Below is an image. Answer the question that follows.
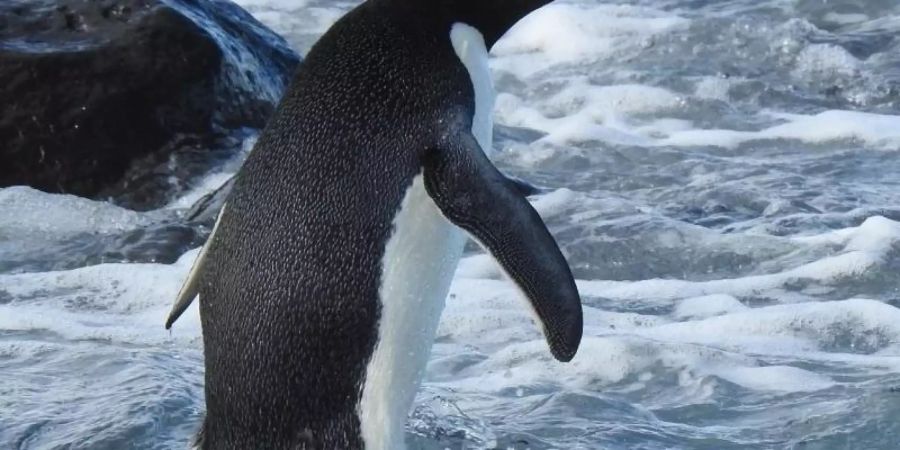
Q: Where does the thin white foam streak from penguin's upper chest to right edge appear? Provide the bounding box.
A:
[497,97,900,150]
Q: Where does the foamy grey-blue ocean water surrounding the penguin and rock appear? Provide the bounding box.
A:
[0,0,900,450]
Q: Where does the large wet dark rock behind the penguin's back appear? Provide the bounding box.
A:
[0,0,299,207]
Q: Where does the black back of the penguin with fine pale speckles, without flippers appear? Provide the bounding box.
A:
[200,0,474,449]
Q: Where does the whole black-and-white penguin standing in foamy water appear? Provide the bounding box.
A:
[165,0,582,450]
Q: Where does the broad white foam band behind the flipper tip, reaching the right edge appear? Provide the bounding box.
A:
[438,270,900,392]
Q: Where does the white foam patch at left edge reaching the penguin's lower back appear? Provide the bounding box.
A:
[0,250,200,344]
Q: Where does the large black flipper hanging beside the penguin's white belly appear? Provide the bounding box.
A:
[424,133,583,361]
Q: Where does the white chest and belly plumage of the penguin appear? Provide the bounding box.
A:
[358,23,494,450]
